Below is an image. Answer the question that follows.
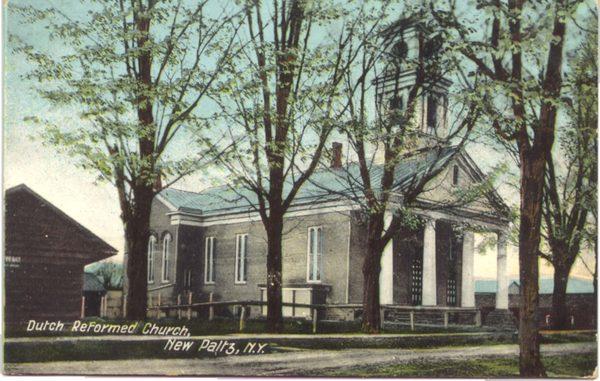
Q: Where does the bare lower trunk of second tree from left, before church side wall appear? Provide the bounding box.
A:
[267,215,283,333]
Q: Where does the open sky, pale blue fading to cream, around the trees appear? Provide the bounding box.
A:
[3,0,590,278]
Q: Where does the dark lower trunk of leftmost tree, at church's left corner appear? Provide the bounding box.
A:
[122,185,153,320]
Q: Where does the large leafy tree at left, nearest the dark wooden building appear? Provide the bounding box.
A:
[10,0,239,319]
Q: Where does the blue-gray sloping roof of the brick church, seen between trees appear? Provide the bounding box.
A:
[160,147,458,215]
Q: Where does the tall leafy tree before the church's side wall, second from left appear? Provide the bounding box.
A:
[201,0,390,331]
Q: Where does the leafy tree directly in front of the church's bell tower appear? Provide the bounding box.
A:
[323,13,489,333]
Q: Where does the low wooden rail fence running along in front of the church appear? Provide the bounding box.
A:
[148,293,481,333]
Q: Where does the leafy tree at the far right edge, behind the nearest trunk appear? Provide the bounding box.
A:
[540,17,598,329]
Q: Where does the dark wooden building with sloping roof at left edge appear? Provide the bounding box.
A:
[4,184,117,326]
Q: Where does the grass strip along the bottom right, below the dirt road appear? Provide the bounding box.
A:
[309,353,597,378]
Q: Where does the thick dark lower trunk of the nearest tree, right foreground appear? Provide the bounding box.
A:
[519,156,545,377]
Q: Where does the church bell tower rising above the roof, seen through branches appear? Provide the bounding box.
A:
[374,17,451,139]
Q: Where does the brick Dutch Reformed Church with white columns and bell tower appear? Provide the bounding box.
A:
[142,17,509,317]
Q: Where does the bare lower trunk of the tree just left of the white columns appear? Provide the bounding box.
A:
[362,233,381,333]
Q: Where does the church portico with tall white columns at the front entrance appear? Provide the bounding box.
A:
[380,212,508,310]
